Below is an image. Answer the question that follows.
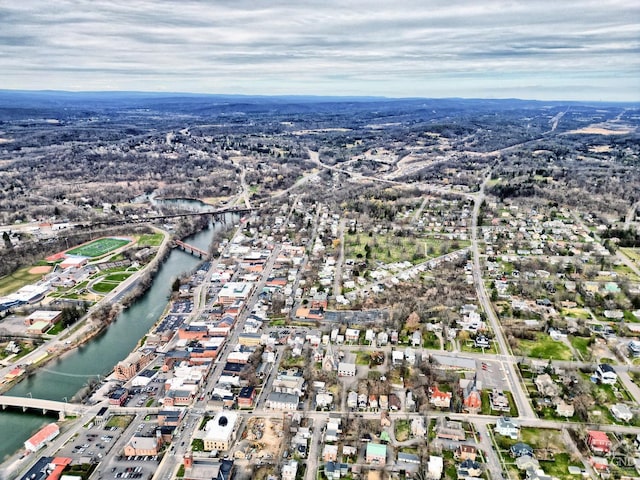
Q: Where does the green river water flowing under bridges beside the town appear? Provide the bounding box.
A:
[0,214,238,462]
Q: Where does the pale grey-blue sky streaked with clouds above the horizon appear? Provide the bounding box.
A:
[0,0,640,101]
